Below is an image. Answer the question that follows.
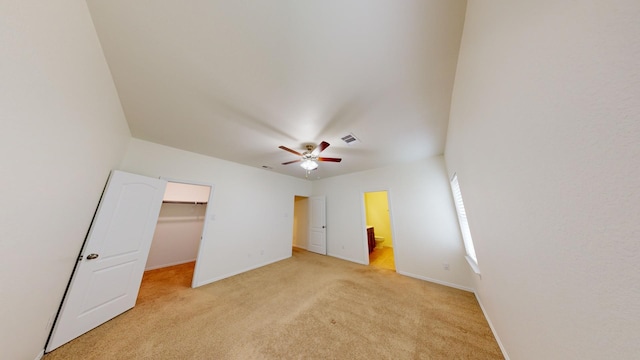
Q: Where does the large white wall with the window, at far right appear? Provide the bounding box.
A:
[445,0,640,360]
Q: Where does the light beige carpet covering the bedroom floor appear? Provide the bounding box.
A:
[43,249,503,360]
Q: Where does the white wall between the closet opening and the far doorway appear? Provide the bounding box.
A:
[121,139,311,284]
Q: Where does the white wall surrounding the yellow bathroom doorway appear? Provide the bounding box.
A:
[313,156,471,289]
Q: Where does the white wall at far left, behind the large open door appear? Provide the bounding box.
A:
[0,0,129,360]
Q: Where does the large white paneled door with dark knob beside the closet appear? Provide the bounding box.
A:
[46,171,166,352]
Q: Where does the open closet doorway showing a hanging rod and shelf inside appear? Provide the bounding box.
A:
[137,181,212,304]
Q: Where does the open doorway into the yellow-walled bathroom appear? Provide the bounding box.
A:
[364,190,396,271]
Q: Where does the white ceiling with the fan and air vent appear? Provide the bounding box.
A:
[87,0,466,179]
